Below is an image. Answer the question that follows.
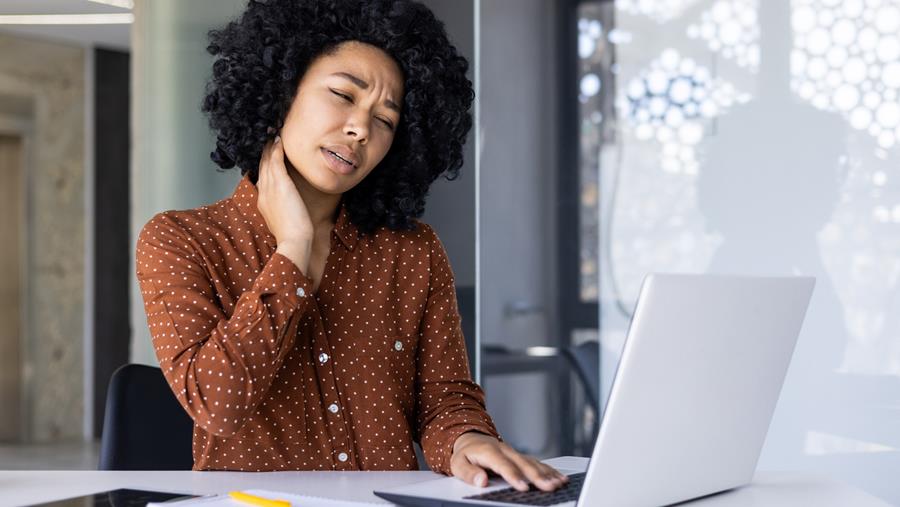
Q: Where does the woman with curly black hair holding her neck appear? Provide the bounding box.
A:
[136,0,566,490]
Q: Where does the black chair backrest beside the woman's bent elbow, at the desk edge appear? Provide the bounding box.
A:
[98,364,194,470]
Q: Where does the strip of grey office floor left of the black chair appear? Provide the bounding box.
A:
[0,442,100,470]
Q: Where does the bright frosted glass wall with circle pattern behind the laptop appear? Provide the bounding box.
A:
[577,0,900,502]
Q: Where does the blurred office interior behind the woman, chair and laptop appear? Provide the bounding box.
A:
[0,0,900,503]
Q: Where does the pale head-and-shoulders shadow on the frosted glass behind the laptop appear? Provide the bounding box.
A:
[698,87,900,500]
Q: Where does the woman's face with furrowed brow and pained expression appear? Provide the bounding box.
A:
[281,41,403,194]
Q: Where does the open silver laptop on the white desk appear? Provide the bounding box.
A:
[374,274,815,507]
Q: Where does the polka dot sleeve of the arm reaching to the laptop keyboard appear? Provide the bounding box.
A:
[416,224,500,475]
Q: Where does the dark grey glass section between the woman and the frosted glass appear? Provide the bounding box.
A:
[475,0,598,456]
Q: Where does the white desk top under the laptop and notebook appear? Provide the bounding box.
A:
[0,458,889,507]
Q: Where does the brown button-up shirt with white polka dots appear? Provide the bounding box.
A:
[136,177,498,473]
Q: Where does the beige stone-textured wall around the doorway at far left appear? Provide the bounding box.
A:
[0,34,85,442]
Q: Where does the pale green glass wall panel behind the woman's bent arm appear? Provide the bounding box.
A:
[130,0,246,366]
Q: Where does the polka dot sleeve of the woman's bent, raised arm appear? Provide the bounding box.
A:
[135,213,312,437]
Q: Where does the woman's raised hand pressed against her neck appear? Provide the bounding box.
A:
[256,137,314,274]
